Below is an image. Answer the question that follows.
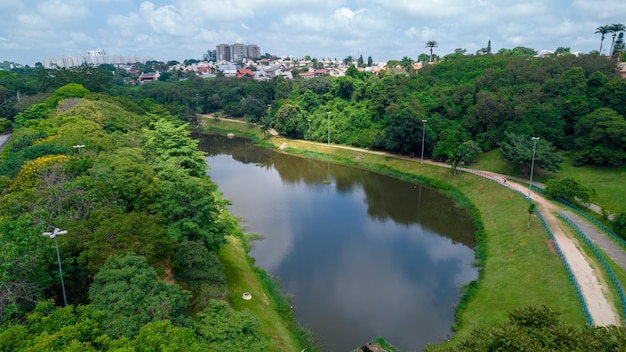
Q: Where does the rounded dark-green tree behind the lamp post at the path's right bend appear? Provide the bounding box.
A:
[500,133,563,175]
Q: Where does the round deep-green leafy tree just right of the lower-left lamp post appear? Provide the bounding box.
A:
[89,253,191,337]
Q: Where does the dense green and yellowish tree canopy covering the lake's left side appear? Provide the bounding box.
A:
[0,84,267,351]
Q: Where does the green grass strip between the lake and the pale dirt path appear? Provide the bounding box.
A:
[201,120,585,341]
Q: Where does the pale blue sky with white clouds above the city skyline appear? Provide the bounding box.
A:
[0,0,626,65]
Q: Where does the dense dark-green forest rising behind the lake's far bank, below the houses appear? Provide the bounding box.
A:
[123,55,626,167]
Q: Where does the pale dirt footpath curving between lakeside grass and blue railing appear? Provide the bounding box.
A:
[204,119,621,326]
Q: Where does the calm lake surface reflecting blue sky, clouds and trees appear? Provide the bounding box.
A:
[195,136,477,351]
